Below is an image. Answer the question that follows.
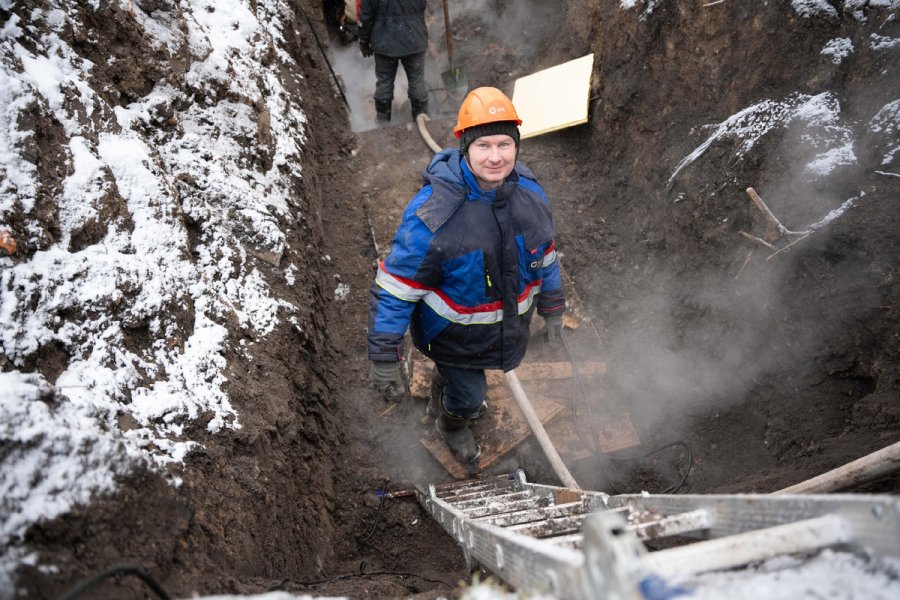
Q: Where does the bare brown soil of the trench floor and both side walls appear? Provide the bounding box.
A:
[12,0,900,598]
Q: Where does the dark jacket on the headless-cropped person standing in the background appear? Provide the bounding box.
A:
[357,0,428,58]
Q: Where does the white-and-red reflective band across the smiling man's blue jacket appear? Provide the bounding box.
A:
[375,263,541,325]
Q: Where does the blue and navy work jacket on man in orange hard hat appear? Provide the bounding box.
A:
[368,149,566,371]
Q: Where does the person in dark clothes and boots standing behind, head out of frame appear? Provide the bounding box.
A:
[358,0,428,123]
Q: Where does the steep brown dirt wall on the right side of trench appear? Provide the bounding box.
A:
[544,2,900,490]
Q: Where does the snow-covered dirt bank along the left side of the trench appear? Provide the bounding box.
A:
[0,0,305,589]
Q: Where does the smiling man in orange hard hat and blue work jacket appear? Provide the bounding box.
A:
[368,87,566,463]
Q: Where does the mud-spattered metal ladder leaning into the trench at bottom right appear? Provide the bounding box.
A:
[416,470,900,599]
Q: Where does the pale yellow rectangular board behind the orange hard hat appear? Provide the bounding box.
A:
[512,54,594,139]
